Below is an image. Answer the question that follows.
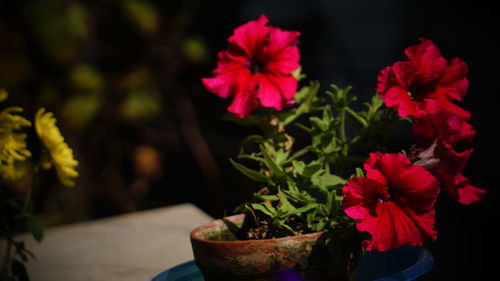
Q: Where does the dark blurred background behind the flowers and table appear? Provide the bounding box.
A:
[0,0,500,280]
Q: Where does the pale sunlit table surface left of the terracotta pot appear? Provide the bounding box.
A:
[0,204,212,281]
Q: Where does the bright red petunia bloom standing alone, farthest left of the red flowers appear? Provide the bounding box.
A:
[202,15,300,118]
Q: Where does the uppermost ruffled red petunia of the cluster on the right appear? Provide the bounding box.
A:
[377,39,470,118]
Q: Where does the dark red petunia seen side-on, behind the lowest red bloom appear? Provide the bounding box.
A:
[415,141,486,205]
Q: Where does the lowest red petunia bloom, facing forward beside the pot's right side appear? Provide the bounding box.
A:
[342,152,439,251]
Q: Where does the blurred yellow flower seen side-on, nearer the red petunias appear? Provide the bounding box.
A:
[35,108,78,186]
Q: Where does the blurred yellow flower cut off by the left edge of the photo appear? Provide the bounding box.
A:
[0,89,31,179]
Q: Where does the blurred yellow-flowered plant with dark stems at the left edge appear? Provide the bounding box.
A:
[0,88,78,281]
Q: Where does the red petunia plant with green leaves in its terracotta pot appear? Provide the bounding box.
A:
[191,15,485,281]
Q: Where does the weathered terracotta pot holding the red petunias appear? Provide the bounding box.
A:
[191,214,356,281]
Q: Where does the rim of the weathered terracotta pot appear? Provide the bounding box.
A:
[189,214,323,245]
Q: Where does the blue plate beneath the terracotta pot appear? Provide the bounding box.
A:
[152,246,434,281]
